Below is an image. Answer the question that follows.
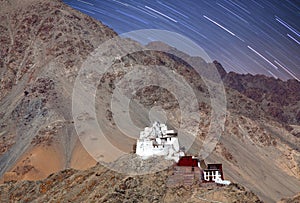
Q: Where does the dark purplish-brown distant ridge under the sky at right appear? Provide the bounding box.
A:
[223,72,300,125]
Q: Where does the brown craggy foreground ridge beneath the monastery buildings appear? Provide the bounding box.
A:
[0,159,261,203]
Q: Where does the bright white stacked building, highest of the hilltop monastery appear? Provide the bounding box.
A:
[136,121,184,162]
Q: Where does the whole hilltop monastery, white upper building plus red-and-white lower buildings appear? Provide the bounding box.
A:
[136,121,230,185]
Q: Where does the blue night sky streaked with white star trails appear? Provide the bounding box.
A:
[64,0,300,80]
